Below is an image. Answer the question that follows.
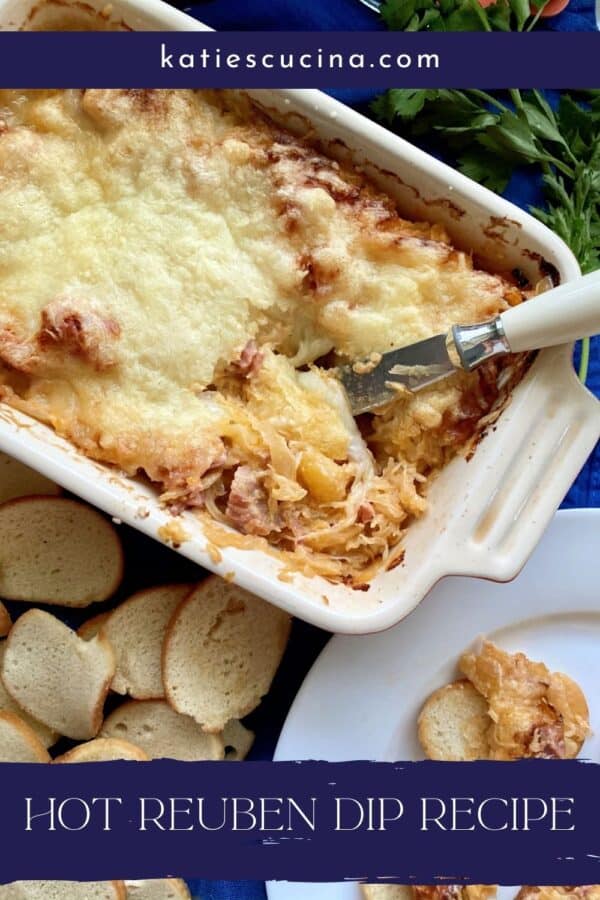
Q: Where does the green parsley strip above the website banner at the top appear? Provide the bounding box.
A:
[381,0,549,31]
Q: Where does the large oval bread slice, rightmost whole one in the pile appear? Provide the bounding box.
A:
[163,576,291,732]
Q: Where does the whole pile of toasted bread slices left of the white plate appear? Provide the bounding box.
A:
[0,454,291,900]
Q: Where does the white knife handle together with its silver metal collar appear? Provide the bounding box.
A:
[452,271,600,372]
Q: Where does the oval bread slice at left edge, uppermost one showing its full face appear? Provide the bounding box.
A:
[0,497,123,607]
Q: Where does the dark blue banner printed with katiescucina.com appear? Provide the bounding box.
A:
[0,31,600,89]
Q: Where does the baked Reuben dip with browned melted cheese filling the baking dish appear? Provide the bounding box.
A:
[0,90,521,586]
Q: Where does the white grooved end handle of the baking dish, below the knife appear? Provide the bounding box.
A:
[446,347,600,581]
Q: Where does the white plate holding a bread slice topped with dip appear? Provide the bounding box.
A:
[267,509,600,900]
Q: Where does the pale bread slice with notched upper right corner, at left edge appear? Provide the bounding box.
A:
[0,609,115,740]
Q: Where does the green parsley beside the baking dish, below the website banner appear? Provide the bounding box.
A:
[372,89,600,380]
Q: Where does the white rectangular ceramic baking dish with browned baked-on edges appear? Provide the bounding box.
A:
[0,0,600,633]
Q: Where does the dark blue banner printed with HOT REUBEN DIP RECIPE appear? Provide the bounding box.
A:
[0,760,600,885]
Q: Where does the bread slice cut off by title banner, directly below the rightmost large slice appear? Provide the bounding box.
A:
[100,700,224,761]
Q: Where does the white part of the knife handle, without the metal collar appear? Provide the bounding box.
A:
[499,271,600,353]
